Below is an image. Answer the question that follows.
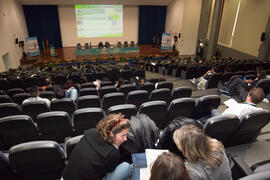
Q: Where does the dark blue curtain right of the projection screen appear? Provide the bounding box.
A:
[139,6,167,44]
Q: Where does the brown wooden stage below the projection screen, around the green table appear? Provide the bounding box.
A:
[21,44,178,65]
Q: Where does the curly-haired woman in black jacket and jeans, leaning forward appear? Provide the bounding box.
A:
[63,114,132,180]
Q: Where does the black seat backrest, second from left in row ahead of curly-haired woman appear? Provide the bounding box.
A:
[36,111,72,143]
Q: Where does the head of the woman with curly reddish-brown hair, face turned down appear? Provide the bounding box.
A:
[96,113,130,146]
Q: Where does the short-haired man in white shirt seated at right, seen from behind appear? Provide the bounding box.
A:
[211,87,265,120]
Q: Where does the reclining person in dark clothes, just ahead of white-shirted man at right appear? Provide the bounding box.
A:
[220,66,266,101]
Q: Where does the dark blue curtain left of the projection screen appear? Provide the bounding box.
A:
[23,5,62,48]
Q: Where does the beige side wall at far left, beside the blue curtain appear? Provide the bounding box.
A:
[0,0,28,72]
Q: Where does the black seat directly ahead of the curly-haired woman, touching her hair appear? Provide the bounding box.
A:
[72,108,105,135]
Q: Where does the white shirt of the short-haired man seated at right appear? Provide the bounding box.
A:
[222,103,263,120]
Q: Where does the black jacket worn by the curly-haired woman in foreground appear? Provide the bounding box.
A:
[63,129,120,180]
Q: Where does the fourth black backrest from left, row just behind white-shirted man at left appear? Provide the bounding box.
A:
[77,95,101,109]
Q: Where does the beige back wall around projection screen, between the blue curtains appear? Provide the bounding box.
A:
[58,5,139,47]
